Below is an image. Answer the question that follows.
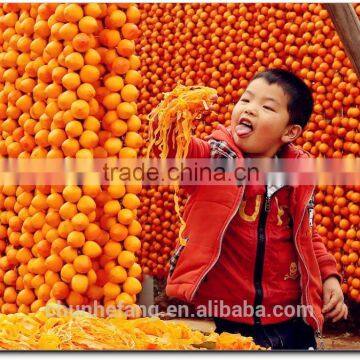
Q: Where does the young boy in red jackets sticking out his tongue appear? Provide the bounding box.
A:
[162,70,347,349]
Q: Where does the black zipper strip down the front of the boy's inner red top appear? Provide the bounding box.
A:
[254,186,270,325]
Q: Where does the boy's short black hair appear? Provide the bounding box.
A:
[251,69,314,128]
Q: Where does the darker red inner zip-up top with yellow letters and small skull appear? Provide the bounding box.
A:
[194,185,301,325]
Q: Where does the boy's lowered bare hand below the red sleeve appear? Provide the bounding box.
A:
[322,276,348,322]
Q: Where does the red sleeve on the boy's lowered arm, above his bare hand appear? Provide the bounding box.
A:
[313,229,342,283]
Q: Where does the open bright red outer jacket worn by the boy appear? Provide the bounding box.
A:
[166,125,340,332]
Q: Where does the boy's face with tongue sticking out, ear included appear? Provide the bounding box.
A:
[231,79,301,157]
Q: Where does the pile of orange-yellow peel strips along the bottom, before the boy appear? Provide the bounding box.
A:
[0,304,262,350]
